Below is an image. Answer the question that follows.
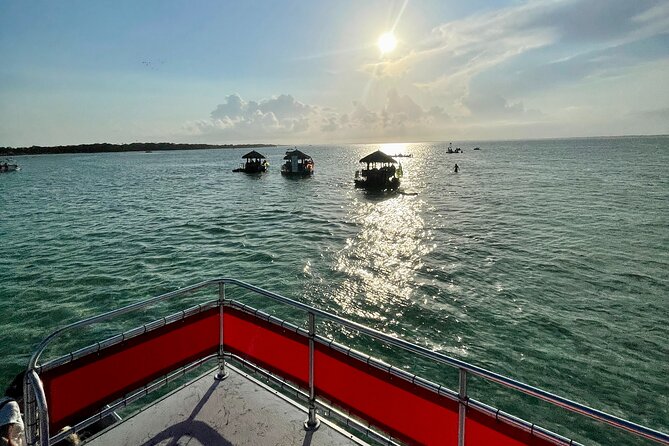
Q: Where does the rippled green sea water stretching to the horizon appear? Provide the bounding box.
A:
[0,137,669,444]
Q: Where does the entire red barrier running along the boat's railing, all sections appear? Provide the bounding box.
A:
[41,307,554,446]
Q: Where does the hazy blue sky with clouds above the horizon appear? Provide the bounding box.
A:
[0,0,669,147]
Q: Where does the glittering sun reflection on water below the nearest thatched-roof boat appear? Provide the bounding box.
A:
[332,195,432,323]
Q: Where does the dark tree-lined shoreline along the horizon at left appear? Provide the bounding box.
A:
[0,142,277,156]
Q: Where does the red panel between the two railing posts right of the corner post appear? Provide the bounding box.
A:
[314,344,458,445]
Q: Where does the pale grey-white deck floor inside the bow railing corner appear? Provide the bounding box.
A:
[86,368,365,446]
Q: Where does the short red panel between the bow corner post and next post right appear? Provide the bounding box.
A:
[223,307,309,387]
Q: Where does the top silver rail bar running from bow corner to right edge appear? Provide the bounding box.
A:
[218,278,669,444]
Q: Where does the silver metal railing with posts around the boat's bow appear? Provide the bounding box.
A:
[24,278,669,446]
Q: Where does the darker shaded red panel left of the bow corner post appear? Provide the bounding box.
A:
[40,308,219,434]
